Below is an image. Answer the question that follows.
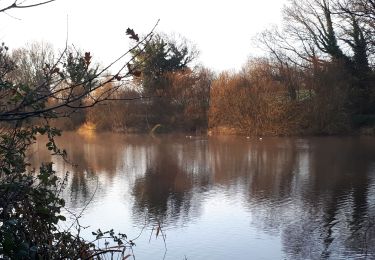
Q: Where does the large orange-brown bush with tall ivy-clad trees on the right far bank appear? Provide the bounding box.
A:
[208,0,375,135]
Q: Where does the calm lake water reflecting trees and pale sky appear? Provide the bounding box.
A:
[30,133,375,260]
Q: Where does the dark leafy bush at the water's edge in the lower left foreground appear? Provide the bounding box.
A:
[0,125,134,259]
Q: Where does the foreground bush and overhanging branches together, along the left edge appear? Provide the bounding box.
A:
[0,7,151,255]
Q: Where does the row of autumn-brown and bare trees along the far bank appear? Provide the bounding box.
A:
[12,0,375,135]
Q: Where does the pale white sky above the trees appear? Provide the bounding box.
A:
[0,0,286,71]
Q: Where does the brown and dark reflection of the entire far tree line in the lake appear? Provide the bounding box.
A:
[30,135,375,259]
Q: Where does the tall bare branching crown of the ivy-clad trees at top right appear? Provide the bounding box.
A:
[259,0,374,113]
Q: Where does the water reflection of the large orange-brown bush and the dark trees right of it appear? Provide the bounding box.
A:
[206,138,375,259]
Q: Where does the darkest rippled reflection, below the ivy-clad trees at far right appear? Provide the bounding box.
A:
[282,138,375,259]
